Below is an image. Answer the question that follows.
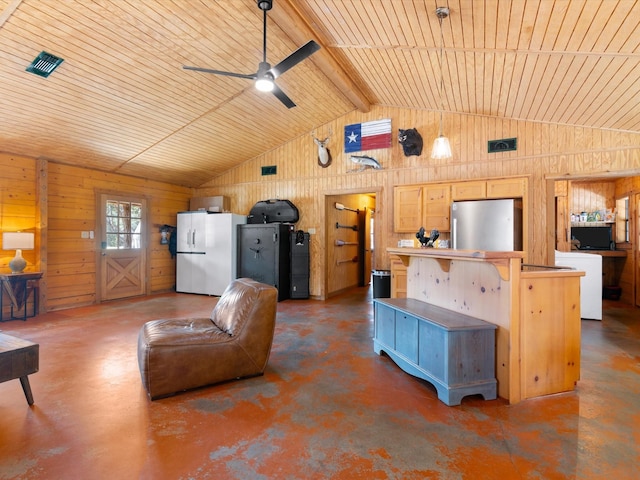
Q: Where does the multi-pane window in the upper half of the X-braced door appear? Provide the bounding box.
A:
[106,200,142,250]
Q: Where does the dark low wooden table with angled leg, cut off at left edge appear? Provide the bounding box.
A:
[0,333,40,405]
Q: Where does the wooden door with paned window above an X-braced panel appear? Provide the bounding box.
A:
[97,194,147,301]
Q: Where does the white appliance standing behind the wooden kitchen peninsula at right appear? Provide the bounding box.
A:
[556,250,602,320]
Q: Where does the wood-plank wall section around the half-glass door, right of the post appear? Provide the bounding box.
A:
[47,163,192,310]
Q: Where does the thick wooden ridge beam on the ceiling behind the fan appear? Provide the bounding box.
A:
[269,0,371,113]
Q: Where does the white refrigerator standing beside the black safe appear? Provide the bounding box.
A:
[176,211,247,295]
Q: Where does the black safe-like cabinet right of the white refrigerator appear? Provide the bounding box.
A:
[238,223,293,301]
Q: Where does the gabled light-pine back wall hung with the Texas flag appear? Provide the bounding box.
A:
[197,107,640,298]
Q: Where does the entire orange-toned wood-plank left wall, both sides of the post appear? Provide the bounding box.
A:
[0,155,193,310]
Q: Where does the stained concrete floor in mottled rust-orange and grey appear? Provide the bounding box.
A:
[0,288,640,480]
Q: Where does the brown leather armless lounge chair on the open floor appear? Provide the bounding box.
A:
[138,278,278,400]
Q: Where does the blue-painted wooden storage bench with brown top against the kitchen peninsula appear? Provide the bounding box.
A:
[373,298,497,406]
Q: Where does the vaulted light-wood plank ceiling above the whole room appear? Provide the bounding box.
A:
[0,0,640,186]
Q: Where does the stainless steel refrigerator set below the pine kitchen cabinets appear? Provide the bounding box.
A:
[451,199,522,251]
